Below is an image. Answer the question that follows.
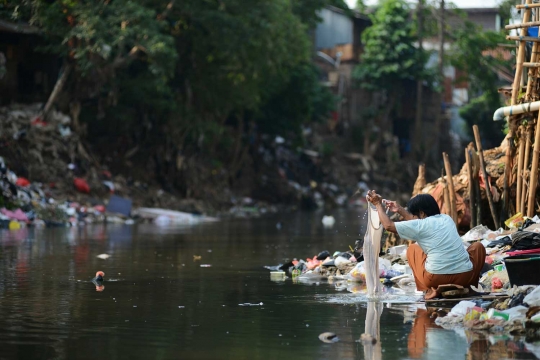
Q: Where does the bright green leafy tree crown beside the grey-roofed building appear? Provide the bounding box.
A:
[354,0,427,90]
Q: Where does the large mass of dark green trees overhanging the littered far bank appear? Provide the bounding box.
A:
[0,0,338,183]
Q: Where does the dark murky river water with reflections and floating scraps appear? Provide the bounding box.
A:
[0,210,540,360]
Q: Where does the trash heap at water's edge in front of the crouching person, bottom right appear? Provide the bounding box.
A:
[435,285,540,336]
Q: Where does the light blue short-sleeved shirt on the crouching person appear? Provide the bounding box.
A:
[395,214,473,274]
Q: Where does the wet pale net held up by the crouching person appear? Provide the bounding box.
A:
[364,202,383,299]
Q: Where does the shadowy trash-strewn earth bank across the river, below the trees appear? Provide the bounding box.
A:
[0,104,414,224]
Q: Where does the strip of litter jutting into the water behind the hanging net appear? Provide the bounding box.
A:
[265,240,416,292]
